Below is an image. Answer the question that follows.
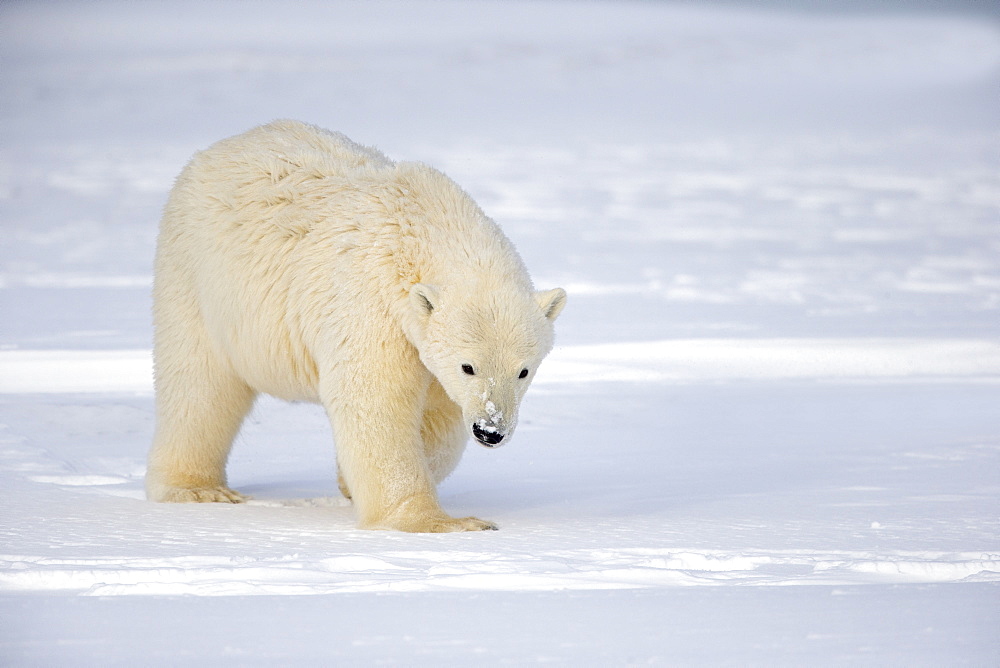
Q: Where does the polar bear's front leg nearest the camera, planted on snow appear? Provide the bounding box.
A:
[323,348,496,533]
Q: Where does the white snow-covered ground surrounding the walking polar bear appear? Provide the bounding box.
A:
[0,0,1000,666]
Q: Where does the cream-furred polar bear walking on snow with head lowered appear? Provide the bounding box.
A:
[146,121,566,532]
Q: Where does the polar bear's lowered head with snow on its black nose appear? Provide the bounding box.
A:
[408,283,566,448]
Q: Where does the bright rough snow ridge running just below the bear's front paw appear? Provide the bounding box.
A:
[0,548,1000,596]
